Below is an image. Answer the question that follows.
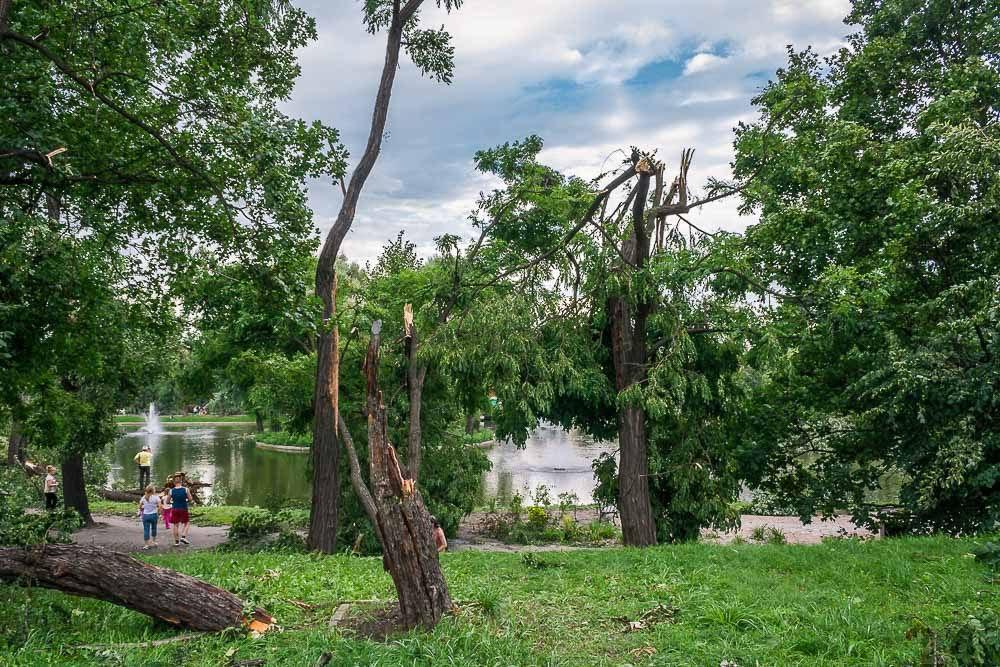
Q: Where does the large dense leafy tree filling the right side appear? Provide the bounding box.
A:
[736,0,1000,533]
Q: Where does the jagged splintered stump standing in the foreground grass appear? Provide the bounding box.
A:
[365,322,453,628]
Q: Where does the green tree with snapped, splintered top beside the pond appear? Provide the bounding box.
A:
[462,137,746,546]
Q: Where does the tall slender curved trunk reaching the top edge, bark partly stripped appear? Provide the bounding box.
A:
[308,0,423,553]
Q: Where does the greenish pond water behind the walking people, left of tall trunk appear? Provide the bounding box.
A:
[109,425,310,505]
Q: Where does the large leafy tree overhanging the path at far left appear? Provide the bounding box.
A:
[0,0,345,516]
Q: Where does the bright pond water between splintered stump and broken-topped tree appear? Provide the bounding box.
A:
[483,424,617,503]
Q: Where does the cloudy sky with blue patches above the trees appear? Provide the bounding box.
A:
[285,0,851,263]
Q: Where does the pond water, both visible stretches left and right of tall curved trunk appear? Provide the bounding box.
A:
[108,424,614,505]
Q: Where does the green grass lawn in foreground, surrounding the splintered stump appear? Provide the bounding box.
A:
[0,538,1000,667]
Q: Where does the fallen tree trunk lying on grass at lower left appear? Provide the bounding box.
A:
[0,544,273,632]
